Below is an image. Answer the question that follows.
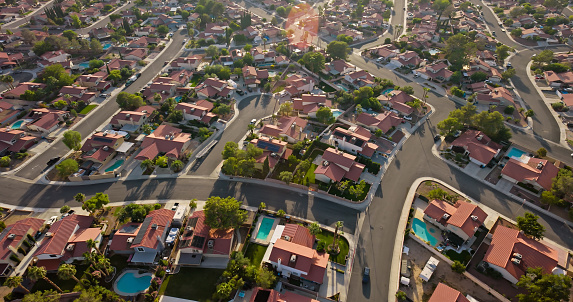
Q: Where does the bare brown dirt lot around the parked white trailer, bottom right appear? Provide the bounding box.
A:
[400,238,497,302]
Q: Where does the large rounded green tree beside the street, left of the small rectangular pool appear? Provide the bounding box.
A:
[204,196,247,230]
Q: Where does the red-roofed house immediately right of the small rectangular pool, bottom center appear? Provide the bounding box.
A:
[263,223,328,285]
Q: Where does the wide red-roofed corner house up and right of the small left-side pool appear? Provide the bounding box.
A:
[135,125,191,160]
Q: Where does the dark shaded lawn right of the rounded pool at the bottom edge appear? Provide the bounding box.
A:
[159,267,224,301]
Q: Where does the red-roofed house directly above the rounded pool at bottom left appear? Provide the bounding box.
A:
[109,209,175,264]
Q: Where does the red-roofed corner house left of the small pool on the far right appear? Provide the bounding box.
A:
[452,130,501,167]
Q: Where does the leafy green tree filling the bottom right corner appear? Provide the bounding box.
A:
[517,267,571,302]
